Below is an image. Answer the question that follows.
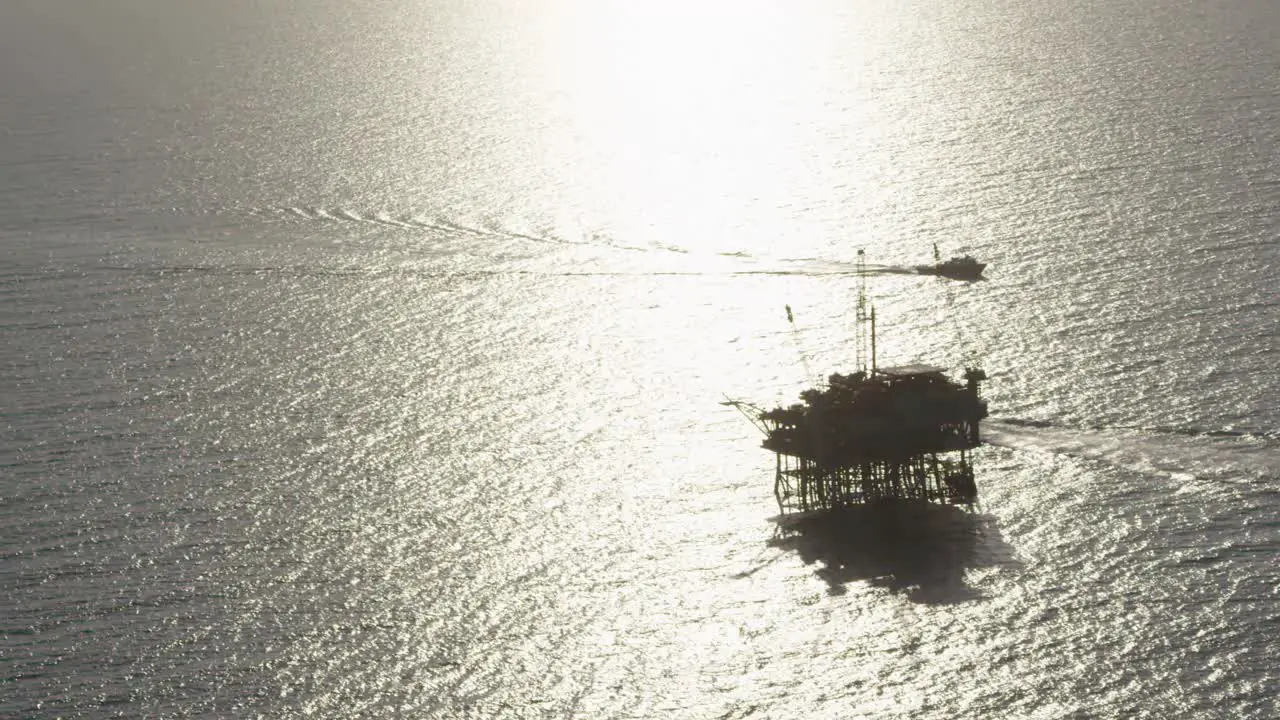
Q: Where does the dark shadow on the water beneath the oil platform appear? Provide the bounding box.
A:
[769,502,1015,605]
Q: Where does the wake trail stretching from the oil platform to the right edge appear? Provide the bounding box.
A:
[982,419,1280,482]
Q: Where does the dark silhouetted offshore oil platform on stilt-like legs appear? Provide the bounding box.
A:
[727,251,987,512]
